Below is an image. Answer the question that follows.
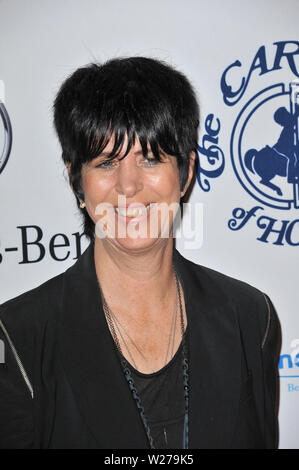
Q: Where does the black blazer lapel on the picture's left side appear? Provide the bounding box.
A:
[60,244,148,449]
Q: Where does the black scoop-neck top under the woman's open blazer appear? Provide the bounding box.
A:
[120,326,188,449]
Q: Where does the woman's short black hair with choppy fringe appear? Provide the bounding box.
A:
[54,57,199,239]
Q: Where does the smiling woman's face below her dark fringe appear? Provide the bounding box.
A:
[82,141,194,251]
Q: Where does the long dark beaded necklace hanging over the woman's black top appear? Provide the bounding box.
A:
[99,269,189,449]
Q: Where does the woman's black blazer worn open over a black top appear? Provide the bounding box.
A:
[0,244,279,449]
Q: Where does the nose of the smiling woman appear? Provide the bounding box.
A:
[115,155,143,198]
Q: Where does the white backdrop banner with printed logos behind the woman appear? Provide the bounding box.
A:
[0,0,299,449]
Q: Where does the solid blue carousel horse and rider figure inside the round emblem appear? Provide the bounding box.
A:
[244,106,299,196]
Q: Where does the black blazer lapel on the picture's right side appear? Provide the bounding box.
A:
[174,251,241,449]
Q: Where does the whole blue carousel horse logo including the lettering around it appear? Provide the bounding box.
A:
[197,41,299,246]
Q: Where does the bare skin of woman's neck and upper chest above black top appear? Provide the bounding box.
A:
[95,239,187,373]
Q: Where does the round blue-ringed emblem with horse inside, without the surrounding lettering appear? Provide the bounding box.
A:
[231,83,299,209]
